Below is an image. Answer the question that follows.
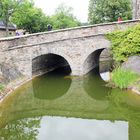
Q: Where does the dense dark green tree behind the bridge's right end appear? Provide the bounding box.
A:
[88,0,132,24]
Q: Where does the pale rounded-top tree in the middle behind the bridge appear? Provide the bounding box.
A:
[51,4,80,29]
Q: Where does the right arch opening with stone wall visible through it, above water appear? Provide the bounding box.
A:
[83,48,113,74]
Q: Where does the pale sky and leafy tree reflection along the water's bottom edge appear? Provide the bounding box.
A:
[0,116,128,140]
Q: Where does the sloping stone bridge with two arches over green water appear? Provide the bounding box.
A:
[0,20,140,85]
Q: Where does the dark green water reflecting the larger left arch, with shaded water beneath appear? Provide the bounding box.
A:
[32,67,71,100]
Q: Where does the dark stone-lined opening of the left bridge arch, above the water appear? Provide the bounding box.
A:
[32,53,72,76]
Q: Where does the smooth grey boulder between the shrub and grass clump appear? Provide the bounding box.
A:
[122,56,140,74]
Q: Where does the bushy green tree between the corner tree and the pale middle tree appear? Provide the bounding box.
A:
[11,0,49,33]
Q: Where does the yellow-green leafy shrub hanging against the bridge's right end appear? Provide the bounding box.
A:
[107,24,140,62]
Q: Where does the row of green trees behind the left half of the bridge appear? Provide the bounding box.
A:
[0,0,80,33]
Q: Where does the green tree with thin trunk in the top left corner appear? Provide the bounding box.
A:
[0,0,22,36]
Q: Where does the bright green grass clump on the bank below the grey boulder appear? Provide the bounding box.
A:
[112,67,139,89]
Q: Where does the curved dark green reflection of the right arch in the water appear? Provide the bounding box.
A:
[83,68,111,100]
